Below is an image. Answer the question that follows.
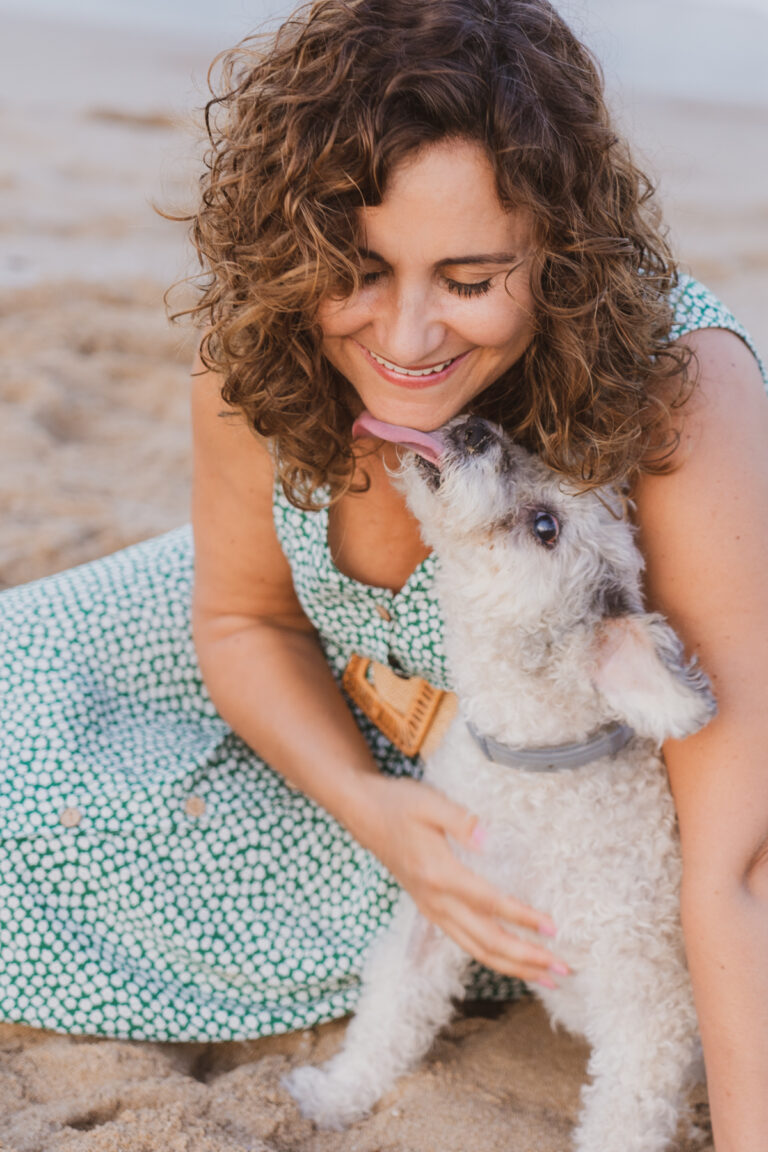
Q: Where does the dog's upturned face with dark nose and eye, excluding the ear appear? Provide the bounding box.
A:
[402,416,642,627]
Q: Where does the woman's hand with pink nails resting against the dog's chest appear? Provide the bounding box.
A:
[350,775,569,987]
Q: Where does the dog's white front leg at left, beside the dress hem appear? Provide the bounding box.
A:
[283,893,469,1129]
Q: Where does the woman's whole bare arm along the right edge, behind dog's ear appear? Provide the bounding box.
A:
[638,331,768,1152]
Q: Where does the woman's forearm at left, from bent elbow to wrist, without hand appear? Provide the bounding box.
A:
[195,621,380,839]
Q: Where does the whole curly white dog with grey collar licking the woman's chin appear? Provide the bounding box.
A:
[284,417,715,1152]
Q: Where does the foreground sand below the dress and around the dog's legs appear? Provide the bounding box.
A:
[0,1000,712,1152]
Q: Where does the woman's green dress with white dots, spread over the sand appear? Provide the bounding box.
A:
[0,280,764,1040]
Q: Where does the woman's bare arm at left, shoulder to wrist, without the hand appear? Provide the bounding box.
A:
[192,354,375,823]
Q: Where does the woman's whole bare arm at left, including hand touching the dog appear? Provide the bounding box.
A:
[192,347,564,980]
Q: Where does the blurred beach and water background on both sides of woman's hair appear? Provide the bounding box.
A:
[0,0,768,585]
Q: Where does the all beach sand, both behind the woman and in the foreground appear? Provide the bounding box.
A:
[0,9,768,1152]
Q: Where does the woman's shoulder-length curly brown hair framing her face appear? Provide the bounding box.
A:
[177,0,691,508]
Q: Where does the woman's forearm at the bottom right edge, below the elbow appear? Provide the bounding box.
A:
[683,876,768,1152]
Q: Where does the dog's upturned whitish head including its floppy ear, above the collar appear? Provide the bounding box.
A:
[401,416,715,741]
